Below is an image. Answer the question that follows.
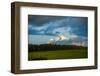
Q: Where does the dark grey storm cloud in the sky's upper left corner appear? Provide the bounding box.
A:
[28,15,69,26]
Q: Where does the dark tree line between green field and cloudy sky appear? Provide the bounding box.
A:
[28,44,87,52]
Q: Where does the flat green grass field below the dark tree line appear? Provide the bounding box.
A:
[28,49,88,61]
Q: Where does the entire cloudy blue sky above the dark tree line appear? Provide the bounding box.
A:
[28,15,88,46]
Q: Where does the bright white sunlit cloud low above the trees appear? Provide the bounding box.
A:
[48,35,87,46]
